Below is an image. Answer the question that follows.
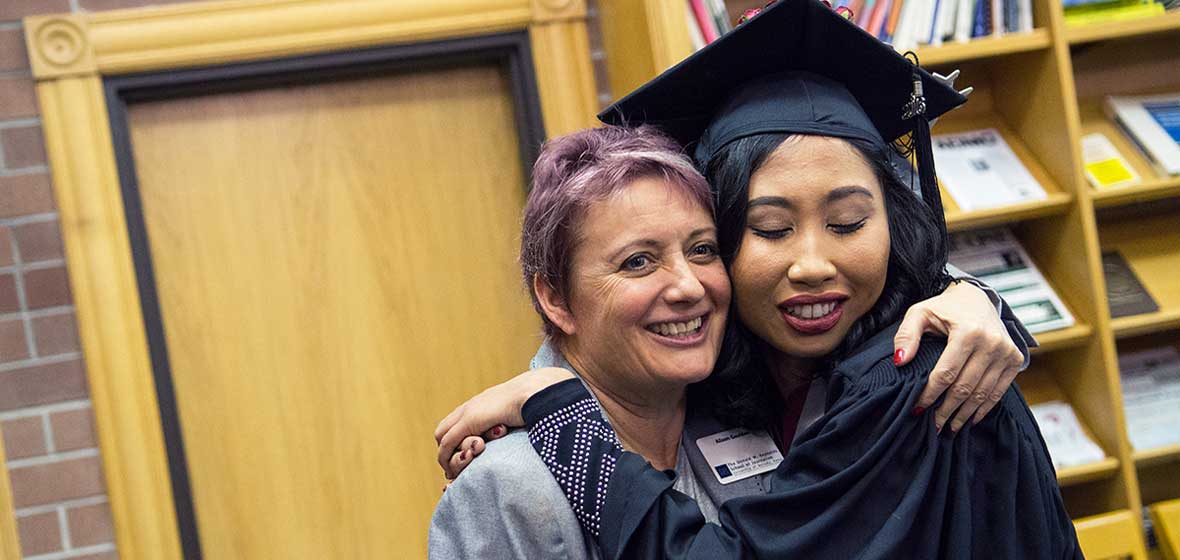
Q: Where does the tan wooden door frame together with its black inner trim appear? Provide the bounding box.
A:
[25,0,597,560]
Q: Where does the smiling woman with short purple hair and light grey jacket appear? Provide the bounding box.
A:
[430,120,1020,559]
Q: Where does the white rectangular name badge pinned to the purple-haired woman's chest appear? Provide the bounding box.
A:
[696,428,782,485]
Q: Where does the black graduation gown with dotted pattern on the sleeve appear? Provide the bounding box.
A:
[524,325,1082,560]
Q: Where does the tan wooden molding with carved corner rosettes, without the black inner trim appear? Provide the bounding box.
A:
[25,0,597,560]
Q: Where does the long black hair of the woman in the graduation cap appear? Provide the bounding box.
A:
[690,133,950,428]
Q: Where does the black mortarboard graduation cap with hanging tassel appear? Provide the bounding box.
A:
[598,0,966,236]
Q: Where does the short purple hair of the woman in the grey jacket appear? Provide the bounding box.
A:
[520,126,713,336]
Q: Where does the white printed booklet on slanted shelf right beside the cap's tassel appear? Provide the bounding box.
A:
[931,129,1048,212]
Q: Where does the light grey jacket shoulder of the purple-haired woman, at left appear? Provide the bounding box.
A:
[430,431,588,558]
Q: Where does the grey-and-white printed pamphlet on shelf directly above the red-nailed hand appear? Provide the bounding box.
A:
[950,228,1074,334]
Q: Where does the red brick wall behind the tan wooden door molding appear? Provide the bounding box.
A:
[0,0,610,560]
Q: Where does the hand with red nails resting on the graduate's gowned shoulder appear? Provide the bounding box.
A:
[893,282,1024,431]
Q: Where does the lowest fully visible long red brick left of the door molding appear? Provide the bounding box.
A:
[8,457,104,509]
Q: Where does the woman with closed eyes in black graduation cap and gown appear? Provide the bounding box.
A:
[443,0,1081,559]
